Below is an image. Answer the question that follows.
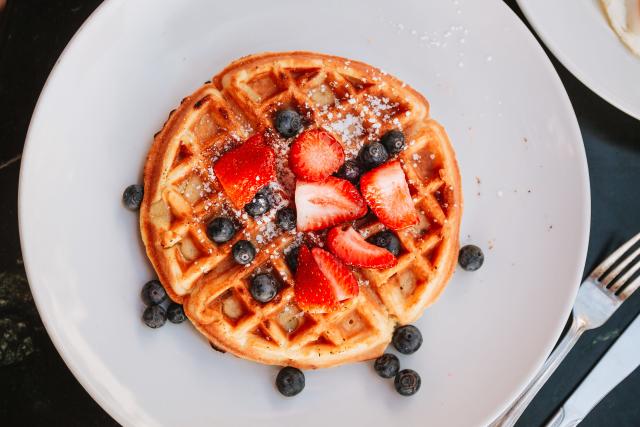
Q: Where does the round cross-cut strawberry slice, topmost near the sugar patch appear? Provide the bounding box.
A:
[289,129,344,181]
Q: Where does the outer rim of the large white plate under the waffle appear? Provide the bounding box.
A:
[18,0,591,425]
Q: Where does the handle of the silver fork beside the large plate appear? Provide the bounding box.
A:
[491,316,587,427]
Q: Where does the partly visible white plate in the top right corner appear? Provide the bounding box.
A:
[517,0,640,120]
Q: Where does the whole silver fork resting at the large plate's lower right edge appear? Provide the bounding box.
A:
[491,233,640,427]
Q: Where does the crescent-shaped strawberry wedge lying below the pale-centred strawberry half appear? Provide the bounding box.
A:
[327,226,398,268]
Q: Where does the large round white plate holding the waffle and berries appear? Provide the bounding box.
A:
[19,0,590,426]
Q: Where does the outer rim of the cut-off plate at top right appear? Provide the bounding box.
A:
[516,0,640,120]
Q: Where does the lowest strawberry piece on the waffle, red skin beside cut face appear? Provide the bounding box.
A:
[293,245,358,313]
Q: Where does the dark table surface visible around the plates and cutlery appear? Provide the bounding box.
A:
[0,0,640,427]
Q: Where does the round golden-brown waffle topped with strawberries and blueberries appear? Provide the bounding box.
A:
[140,52,462,369]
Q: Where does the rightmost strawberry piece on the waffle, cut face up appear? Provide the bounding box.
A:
[360,160,419,230]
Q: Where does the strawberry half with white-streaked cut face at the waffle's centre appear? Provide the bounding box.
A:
[295,176,367,231]
